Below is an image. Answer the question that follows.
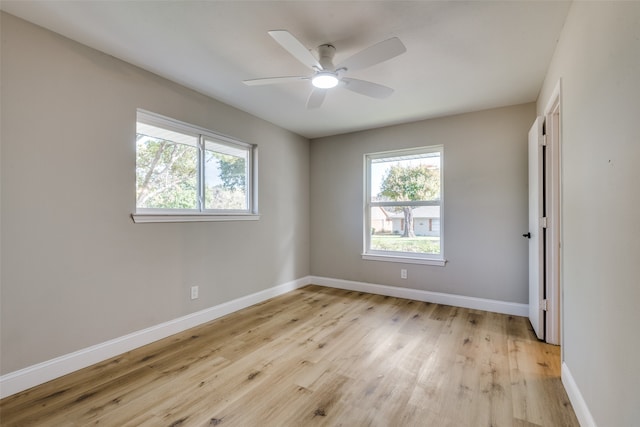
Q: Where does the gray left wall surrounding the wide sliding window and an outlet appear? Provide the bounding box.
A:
[0,13,309,374]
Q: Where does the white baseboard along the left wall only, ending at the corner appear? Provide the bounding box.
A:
[0,277,309,399]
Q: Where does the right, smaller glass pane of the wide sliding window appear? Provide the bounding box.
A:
[204,140,249,211]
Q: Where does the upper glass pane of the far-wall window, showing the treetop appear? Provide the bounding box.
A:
[369,152,440,202]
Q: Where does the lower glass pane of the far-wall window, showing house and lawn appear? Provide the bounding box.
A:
[370,206,440,255]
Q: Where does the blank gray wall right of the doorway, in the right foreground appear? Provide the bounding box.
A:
[538,2,640,427]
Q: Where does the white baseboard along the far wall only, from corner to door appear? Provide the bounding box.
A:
[309,276,529,317]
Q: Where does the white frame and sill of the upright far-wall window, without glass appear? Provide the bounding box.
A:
[362,145,446,267]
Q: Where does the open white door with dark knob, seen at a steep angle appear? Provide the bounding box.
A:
[529,117,545,339]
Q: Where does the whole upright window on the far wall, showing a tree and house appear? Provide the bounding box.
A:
[363,146,445,265]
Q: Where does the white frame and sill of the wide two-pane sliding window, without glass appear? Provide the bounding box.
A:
[131,109,260,223]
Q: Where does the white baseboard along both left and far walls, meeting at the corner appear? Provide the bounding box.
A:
[0,276,528,400]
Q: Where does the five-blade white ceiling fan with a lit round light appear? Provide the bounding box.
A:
[243,30,407,109]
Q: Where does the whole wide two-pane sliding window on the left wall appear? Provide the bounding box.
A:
[133,111,257,222]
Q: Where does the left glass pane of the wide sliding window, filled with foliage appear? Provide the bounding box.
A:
[136,123,198,209]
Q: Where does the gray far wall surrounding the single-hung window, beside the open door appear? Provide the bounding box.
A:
[311,104,535,304]
